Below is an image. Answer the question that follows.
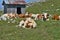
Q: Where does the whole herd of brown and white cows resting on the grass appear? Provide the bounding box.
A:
[0,12,60,28]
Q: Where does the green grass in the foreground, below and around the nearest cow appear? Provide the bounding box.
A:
[0,21,60,40]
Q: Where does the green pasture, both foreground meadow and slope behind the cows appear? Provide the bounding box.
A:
[0,0,60,40]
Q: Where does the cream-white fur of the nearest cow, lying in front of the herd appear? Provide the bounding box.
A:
[19,18,37,28]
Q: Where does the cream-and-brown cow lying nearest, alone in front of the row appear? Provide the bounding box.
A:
[18,18,37,28]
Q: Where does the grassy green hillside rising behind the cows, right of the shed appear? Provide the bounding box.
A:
[26,0,60,14]
